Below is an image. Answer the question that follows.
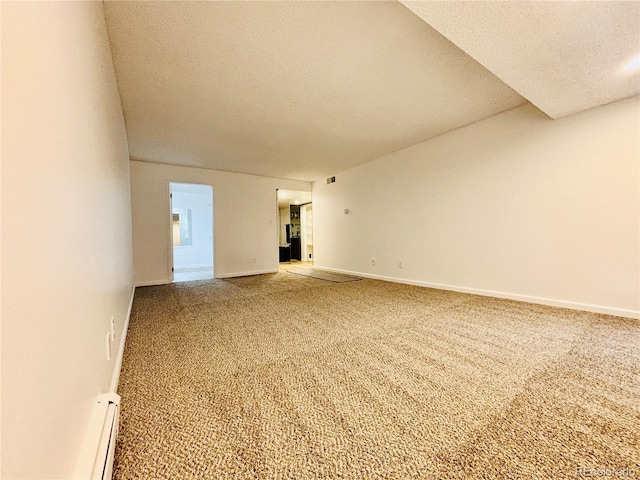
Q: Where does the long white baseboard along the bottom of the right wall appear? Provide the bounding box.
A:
[314,265,640,319]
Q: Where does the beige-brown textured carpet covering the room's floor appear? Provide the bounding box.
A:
[114,272,640,479]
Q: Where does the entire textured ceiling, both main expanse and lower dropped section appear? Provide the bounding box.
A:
[105,1,639,181]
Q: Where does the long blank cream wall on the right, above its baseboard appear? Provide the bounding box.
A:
[313,97,640,316]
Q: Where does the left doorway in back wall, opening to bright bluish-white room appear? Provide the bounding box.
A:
[169,183,214,282]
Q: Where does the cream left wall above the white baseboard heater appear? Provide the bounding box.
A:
[1,2,133,479]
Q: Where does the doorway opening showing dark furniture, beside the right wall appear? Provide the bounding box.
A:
[277,190,313,267]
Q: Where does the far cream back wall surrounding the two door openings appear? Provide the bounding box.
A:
[131,161,311,285]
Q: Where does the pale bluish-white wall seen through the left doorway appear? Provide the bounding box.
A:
[172,184,213,270]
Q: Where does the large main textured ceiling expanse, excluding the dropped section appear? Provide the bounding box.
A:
[105,1,525,181]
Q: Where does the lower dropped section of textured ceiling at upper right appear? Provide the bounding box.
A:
[400,0,640,118]
